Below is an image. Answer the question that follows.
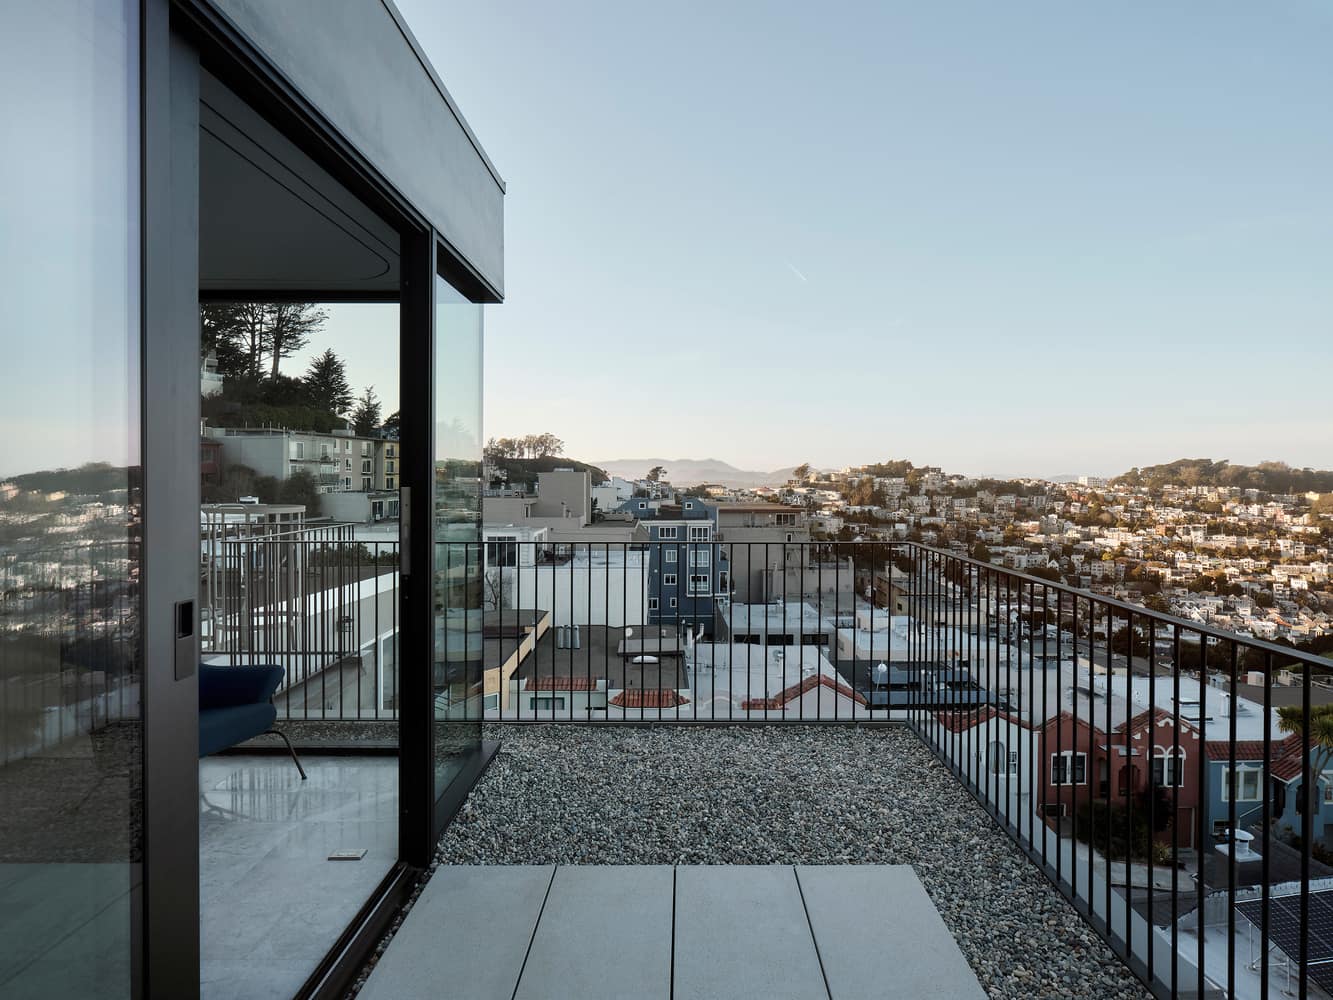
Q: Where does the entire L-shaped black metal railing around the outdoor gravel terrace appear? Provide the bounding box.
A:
[465,541,1333,997]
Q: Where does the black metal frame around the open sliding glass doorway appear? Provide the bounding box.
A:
[143,0,500,1000]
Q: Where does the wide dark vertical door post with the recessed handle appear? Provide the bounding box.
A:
[135,0,199,997]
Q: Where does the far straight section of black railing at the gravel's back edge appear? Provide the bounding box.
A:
[460,544,906,723]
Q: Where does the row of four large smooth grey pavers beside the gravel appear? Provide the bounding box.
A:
[360,865,985,1000]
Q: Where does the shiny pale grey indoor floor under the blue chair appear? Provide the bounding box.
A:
[199,755,399,1000]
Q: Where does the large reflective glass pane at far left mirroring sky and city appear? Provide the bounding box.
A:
[0,0,143,997]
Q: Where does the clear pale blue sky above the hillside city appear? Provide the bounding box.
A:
[399,0,1333,475]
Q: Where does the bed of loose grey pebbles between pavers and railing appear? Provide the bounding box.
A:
[352,725,1149,1000]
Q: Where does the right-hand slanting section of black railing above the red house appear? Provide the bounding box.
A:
[904,545,1333,997]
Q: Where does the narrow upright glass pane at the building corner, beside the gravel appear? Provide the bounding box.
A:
[433,279,483,796]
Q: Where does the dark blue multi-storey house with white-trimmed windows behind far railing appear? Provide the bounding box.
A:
[640,497,730,635]
